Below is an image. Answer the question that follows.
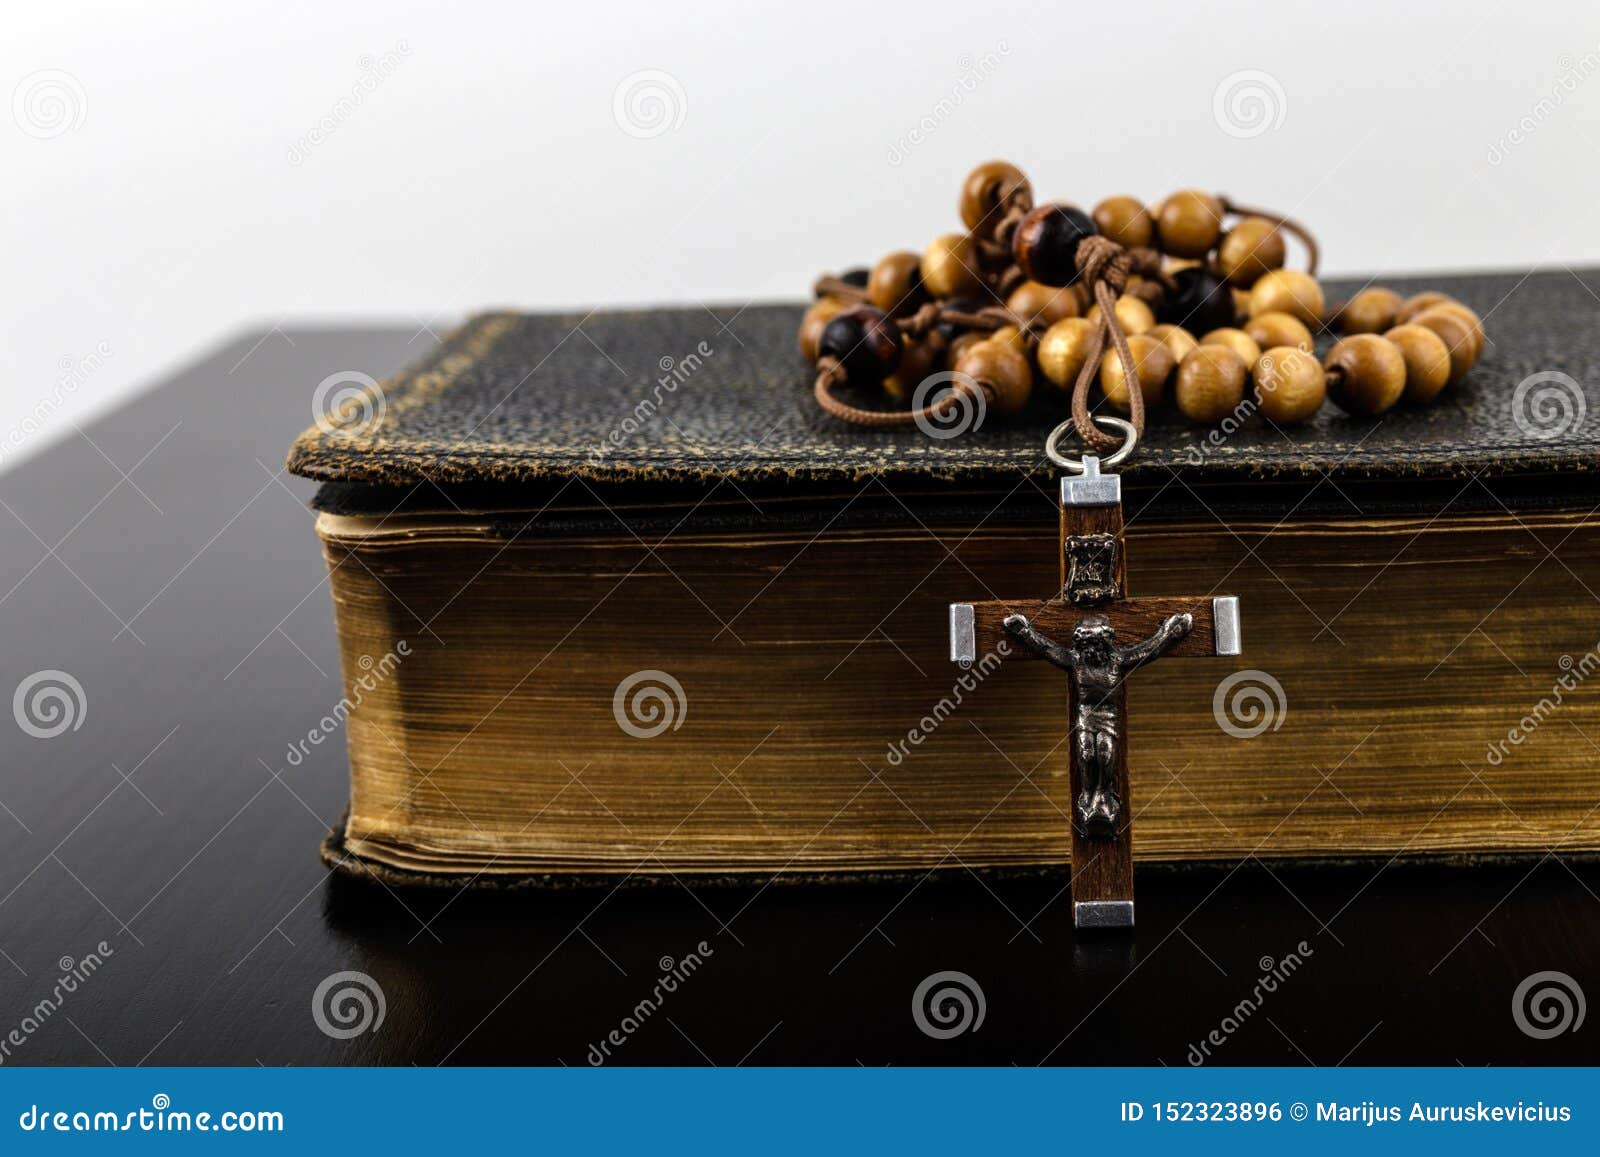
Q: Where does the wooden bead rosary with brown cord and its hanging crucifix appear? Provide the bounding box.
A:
[800,162,1485,928]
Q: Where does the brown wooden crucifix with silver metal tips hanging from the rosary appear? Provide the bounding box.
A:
[950,454,1240,928]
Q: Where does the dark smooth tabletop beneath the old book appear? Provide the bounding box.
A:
[0,328,1600,1066]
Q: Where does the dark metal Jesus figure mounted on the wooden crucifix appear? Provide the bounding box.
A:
[1002,613,1195,840]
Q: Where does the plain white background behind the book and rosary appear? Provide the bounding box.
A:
[0,0,1600,467]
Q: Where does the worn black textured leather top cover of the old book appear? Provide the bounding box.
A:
[290,269,1600,509]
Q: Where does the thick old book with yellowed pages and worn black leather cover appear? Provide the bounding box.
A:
[290,272,1600,883]
